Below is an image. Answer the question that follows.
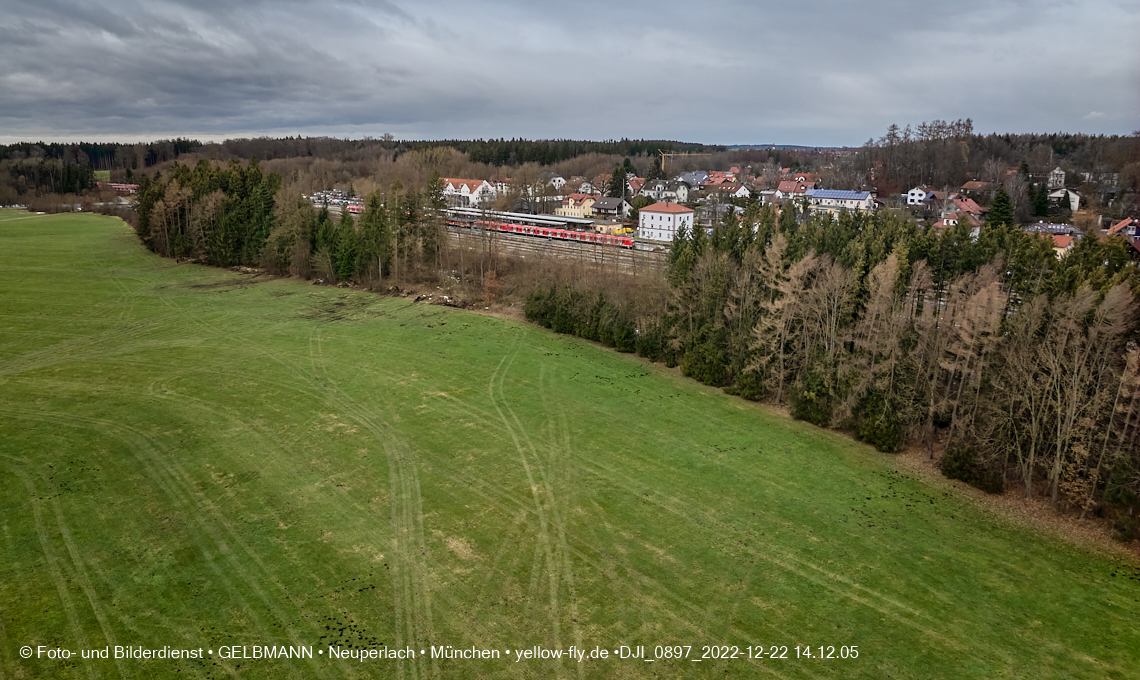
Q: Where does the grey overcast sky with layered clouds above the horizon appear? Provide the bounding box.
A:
[0,0,1140,146]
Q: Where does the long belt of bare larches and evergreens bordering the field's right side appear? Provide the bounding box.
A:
[526,207,1140,533]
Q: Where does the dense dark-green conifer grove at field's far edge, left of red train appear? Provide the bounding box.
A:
[136,159,462,289]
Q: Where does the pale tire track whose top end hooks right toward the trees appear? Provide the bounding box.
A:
[487,338,563,674]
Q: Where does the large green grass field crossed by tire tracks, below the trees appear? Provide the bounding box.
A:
[0,211,1140,679]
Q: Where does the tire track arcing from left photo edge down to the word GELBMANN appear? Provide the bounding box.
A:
[0,408,303,678]
